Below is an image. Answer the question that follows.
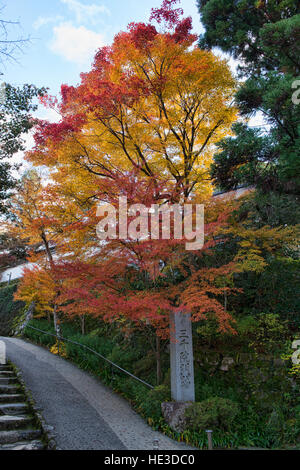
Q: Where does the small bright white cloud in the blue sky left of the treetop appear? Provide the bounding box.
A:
[50,23,104,65]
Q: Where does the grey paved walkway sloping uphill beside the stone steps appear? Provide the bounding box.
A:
[0,337,195,450]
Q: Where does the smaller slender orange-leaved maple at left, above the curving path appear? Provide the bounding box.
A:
[11,170,66,327]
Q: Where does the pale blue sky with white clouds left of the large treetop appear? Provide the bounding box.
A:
[0,0,202,103]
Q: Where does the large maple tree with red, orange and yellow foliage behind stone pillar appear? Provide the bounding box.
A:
[12,0,241,364]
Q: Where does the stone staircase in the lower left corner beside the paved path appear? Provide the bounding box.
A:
[0,364,47,450]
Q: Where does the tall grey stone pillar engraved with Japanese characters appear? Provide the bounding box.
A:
[170,313,195,401]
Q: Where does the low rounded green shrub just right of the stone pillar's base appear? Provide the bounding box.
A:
[185,397,239,431]
